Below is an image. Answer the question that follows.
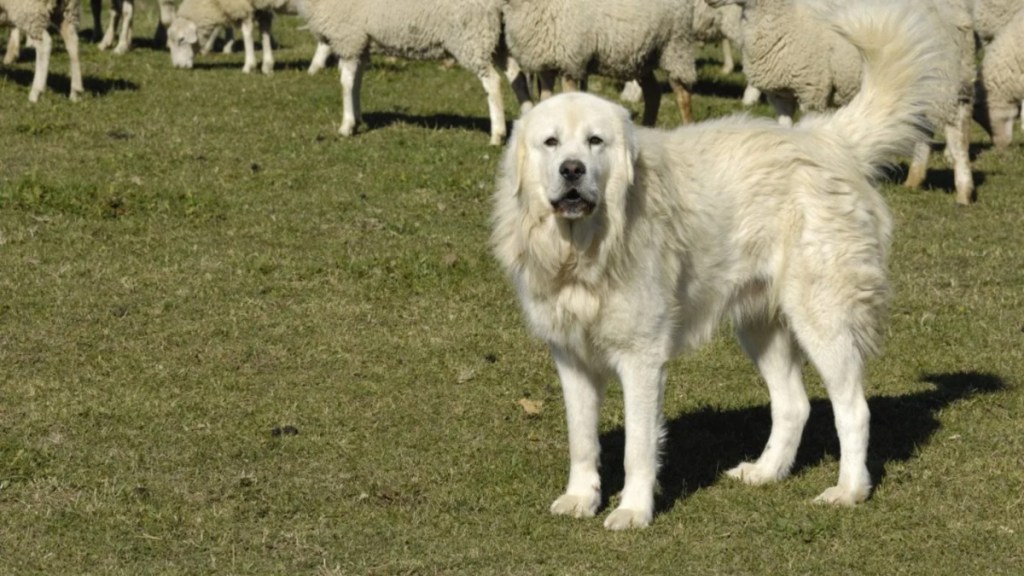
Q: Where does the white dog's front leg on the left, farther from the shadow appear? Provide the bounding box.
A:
[551,346,606,518]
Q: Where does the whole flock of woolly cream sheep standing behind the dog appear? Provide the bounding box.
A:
[0,0,1024,203]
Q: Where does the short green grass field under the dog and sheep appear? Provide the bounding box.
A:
[0,4,1024,575]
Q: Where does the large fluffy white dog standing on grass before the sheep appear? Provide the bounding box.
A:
[493,1,955,530]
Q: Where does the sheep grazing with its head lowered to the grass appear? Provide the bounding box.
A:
[167,0,289,74]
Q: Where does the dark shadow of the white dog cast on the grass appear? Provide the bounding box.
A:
[601,372,1006,511]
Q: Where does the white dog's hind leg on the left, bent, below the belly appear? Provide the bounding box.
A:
[725,322,811,485]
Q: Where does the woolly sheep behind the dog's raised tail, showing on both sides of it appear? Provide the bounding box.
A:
[706,0,975,204]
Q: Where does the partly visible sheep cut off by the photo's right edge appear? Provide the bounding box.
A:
[979,9,1024,149]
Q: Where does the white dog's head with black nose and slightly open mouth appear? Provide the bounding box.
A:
[499,92,637,220]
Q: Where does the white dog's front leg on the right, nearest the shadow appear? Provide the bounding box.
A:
[604,359,665,530]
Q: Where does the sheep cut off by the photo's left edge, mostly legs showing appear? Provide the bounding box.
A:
[0,0,85,102]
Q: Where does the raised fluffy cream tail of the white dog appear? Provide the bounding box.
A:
[806,0,959,176]
